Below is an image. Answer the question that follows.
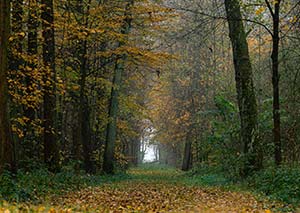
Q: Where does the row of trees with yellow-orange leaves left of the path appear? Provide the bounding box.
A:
[0,0,172,173]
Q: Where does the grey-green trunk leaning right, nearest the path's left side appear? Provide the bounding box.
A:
[103,0,133,174]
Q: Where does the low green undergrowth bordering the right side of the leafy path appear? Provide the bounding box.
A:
[185,166,300,212]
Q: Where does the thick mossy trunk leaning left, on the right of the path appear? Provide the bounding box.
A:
[225,0,261,176]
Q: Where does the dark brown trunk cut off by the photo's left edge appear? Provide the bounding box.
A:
[0,0,16,173]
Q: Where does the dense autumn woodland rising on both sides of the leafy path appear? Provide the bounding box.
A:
[0,0,300,211]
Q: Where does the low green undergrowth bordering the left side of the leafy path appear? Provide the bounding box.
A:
[0,168,129,203]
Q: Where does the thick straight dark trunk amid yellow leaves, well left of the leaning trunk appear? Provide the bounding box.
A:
[42,0,59,172]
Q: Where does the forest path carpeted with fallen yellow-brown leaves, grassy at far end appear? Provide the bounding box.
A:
[55,168,270,213]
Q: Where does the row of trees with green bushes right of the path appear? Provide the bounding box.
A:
[152,0,299,176]
